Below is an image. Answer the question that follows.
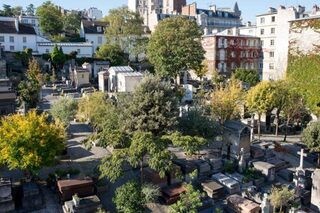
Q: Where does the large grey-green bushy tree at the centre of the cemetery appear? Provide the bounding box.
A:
[123,75,179,135]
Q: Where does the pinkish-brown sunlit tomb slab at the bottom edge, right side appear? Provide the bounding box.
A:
[227,195,261,213]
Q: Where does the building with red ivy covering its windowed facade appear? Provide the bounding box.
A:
[202,28,262,77]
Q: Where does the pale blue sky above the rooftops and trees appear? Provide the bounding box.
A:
[0,0,319,22]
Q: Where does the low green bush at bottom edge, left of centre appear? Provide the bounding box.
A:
[113,181,159,213]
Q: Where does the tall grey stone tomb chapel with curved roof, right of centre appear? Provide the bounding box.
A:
[222,121,251,160]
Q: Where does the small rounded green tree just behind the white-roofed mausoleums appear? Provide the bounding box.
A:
[96,44,127,66]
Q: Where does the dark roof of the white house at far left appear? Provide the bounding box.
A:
[0,21,36,35]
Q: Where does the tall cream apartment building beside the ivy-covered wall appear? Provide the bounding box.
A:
[256,6,306,80]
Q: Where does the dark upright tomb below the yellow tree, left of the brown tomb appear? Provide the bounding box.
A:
[22,182,44,211]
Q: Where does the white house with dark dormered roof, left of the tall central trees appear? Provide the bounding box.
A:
[80,20,109,52]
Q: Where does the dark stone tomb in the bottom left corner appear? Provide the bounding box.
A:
[0,178,15,212]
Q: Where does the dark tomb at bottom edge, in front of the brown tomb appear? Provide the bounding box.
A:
[62,195,101,213]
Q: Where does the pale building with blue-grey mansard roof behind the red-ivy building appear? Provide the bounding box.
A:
[181,3,242,34]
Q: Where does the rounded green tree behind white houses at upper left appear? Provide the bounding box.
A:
[36,1,63,36]
